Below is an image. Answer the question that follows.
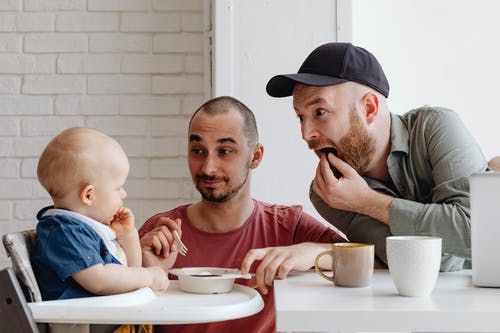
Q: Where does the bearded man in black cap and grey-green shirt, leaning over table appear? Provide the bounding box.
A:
[266,43,487,271]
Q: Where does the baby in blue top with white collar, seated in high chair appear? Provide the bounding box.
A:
[31,127,168,300]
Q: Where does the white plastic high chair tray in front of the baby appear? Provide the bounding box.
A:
[28,281,264,332]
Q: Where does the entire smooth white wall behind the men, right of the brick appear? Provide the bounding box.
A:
[213,0,500,226]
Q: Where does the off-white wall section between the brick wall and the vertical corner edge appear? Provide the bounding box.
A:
[214,0,336,223]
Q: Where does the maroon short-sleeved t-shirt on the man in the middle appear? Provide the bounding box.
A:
[139,200,345,333]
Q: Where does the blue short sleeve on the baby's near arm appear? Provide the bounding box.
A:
[43,222,104,280]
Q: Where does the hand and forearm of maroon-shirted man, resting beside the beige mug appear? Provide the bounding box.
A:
[241,243,331,295]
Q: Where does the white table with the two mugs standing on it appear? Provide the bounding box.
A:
[274,270,500,332]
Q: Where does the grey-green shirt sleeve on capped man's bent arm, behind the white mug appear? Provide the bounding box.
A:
[389,111,486,259]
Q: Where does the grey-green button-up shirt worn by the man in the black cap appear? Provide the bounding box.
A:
[310,107,487,271]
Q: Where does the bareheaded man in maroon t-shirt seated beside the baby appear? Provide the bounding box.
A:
[139,96,345,333]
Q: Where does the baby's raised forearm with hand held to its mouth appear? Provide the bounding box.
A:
[111,207,142,267]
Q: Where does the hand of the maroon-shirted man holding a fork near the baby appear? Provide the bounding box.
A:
[141,217,182,270]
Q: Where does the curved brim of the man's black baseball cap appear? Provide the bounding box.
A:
[266,73,348,97]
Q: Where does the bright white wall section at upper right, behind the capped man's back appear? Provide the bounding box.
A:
[353,0,500,158]
